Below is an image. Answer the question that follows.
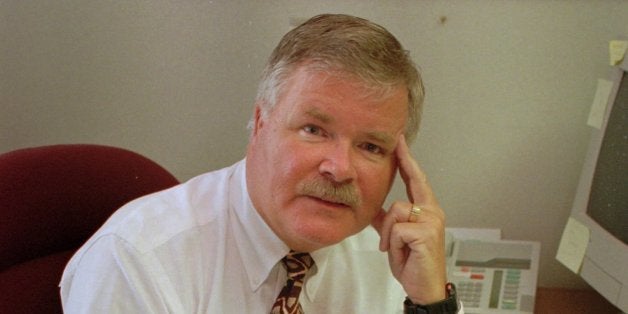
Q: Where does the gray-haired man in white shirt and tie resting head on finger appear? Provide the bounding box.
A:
[61,15,458,313]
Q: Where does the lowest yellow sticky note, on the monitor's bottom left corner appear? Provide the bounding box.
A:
[556,217,591,274]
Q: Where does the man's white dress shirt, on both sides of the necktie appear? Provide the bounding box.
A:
[60,160,462,314]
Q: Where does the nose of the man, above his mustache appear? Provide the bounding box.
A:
[319,143,356,183]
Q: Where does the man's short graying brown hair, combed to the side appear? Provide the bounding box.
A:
[249,14,424,143]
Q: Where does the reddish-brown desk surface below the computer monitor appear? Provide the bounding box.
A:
[534,287,621,314]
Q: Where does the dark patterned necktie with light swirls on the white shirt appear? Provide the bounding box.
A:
[270,251,314,314]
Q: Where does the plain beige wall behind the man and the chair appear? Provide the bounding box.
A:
[0,0,628,286]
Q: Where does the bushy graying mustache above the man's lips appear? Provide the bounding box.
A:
[298,178,362,208]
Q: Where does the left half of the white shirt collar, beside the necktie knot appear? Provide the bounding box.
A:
[230,159,290,291]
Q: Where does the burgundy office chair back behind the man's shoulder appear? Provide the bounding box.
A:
[0,144,179,313]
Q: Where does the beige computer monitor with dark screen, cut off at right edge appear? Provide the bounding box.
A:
[571,54,628,313]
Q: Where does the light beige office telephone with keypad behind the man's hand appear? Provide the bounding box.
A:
[446,229,541,314]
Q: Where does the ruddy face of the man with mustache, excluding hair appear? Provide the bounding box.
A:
[247,68,408,251]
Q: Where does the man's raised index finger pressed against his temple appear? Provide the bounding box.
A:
[395,135,437,206]
